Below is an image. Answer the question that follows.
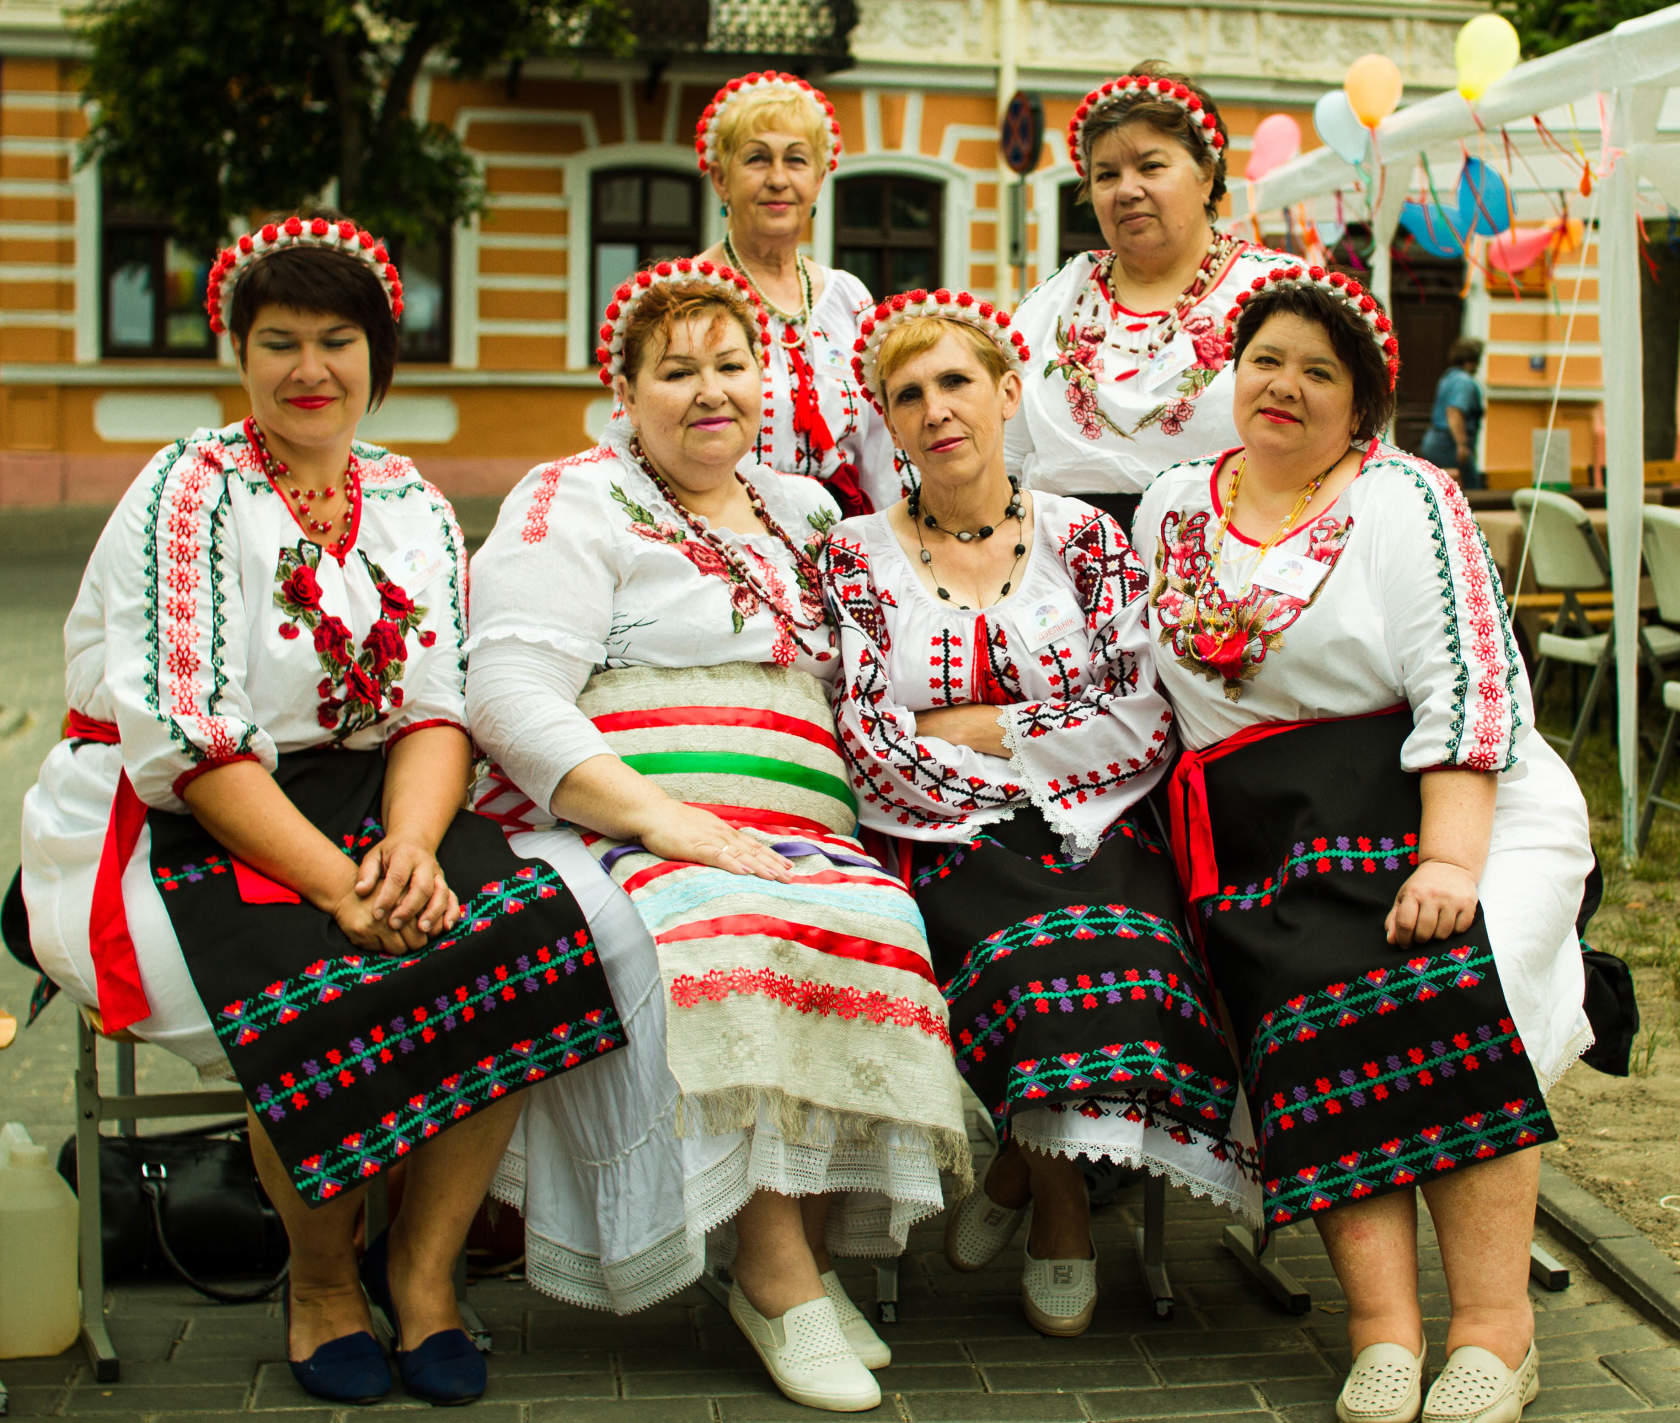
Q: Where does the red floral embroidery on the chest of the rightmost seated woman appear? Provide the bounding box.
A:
[1149,509,1354,702]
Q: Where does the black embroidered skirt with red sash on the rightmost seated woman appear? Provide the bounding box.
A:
[1171,711,1557,1226]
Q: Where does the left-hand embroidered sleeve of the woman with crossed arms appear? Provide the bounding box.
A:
[818,524,1026,840]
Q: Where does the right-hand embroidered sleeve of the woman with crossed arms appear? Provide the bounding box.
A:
[1003,509,1173,860]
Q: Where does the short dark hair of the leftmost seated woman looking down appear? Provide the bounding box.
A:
[227,207,396,410]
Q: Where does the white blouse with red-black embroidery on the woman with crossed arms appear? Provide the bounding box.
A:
[822,494,1173,859]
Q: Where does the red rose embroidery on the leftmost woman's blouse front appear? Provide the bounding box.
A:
[274,539,437,741]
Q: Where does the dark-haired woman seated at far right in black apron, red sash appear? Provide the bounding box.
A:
[1137,265,1593,1423]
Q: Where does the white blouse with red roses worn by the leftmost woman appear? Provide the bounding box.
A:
[64,416,467,811]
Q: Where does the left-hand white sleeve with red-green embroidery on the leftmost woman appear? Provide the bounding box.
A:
[94,432,277,811]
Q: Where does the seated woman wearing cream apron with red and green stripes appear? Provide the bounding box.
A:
[469,259,968,1410]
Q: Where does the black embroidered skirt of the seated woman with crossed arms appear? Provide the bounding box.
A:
[911,810,1243,1198]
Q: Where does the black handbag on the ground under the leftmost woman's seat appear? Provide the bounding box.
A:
[59,1122,291,1304]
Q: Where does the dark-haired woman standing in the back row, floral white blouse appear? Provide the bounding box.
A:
[1005,62,1289,529]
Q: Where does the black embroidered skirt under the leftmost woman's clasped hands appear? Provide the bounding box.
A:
[146,751,625,1206]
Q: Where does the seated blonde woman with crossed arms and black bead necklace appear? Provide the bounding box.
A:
[822,291,1252,1336]
